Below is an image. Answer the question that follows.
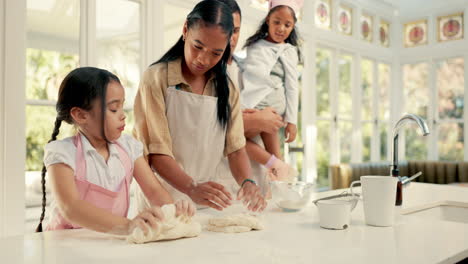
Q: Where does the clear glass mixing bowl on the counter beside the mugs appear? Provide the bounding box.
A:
[270,181,315,212]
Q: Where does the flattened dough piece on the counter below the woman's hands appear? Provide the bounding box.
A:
[206,214,265,233]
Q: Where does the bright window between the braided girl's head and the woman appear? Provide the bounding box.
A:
[96,0,141,134]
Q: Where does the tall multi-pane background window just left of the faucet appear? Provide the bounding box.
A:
[315,47,391,186]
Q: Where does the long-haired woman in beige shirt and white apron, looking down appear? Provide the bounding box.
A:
[134,0,266,211]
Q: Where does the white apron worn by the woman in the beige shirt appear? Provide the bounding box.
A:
[136,86,226,211]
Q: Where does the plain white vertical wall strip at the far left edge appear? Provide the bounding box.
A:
[0,0,26,237]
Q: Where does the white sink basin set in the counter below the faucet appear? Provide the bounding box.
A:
[401,201,468,224]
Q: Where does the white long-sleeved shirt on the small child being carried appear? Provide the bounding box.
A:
[241,39,299,124]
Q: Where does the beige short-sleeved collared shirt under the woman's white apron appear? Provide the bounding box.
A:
[133,59,245,158]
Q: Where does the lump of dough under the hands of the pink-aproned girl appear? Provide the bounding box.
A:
[127,204,201,244]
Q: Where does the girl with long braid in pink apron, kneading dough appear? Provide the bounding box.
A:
[36,67,194,235]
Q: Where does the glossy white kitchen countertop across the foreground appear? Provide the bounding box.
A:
[0,183,468,264]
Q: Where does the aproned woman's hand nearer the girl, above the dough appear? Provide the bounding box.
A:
[187,181,232,211]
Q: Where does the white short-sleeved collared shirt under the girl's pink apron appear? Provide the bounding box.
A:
[44,134,143,191]
